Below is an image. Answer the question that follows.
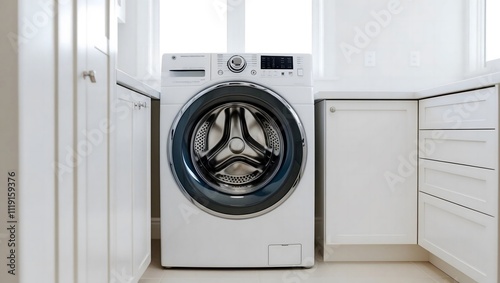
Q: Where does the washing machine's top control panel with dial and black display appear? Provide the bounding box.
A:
[162,53,312,86]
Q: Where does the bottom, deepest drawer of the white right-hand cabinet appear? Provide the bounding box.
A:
[418,193,498,283]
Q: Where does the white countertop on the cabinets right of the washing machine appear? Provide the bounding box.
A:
[314,72,500,100]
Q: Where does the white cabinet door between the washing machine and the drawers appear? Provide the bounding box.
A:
[324,101,417,244]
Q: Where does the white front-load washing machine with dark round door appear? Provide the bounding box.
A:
[160,54,314,267]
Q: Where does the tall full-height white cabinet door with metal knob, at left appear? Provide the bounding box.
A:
[75,0,110,283]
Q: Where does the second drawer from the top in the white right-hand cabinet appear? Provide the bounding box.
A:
[419,130,498,169]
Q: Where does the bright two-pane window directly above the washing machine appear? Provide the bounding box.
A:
[159,0,312,54]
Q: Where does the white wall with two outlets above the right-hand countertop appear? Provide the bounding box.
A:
[317,0,467,91]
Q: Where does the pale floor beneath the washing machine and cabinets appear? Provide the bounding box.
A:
[139,240,455,283]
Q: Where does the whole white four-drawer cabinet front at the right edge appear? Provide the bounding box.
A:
[418,86,499,283]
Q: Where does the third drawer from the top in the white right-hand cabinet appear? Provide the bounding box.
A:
[418,159,498,216]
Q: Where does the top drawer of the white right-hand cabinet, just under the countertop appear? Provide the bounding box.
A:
[419,87,498,129]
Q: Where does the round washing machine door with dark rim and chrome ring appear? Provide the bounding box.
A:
[168,82,306,218]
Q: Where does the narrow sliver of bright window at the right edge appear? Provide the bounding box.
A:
[486,0,500,62]
